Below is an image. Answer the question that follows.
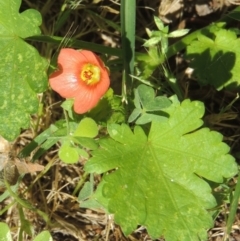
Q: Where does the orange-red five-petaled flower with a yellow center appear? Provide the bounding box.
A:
[49,48,110,114]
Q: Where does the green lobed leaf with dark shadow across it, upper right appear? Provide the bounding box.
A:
[186,29,240,90]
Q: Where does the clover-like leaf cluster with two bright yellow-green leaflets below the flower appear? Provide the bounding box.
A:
[19,117,98,164]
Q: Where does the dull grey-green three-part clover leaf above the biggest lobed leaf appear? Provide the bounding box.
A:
[128,85,171,125]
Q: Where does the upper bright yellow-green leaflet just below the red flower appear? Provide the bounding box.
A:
[73,117,98,138]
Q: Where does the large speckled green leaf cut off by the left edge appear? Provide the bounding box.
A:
[0,0,47,140]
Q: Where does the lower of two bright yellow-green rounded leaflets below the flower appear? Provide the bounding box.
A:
[58,142,79,164]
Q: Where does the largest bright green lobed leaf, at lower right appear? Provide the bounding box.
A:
[85,100,237,241]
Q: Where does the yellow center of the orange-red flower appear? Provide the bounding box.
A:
[80,64,101,85]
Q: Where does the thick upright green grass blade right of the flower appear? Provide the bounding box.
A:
[120,0,136,101]
